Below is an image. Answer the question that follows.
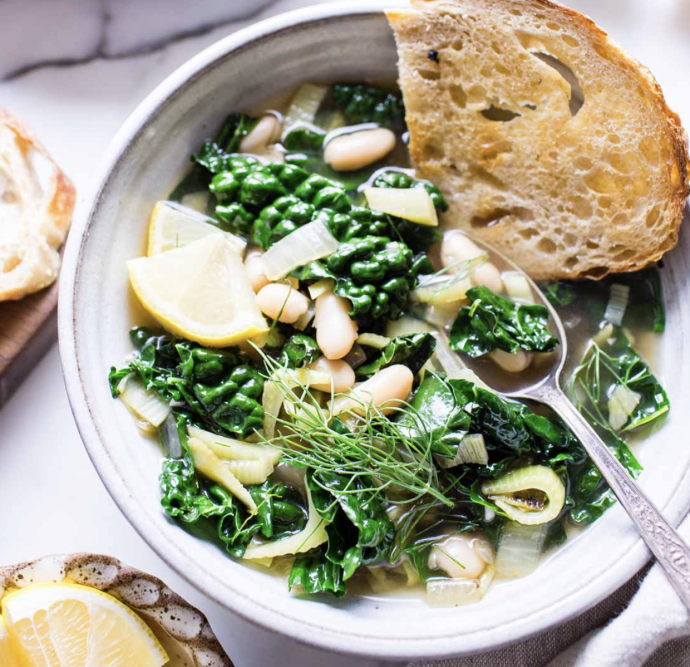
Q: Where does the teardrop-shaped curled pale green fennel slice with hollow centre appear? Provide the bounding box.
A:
[482,466,565,526]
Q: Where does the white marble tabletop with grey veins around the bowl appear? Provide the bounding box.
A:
[0,0,690,667]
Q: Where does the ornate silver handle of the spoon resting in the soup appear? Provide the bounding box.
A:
[531,385,690,610]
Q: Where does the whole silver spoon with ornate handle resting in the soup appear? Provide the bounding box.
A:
[446,234,690,610]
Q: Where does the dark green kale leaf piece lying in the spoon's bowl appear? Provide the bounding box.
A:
[450,287,558,357]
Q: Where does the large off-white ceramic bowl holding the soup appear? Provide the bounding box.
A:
[59,2,690,659]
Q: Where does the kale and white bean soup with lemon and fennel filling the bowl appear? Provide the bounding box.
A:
[110,83,669,606]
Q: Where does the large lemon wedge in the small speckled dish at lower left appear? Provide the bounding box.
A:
[2,583,168,667]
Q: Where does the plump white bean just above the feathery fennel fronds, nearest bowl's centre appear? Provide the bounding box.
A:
[333,364,414,415]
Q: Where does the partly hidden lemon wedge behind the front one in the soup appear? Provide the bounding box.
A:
[147,201,247,257]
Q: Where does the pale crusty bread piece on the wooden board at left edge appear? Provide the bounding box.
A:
[0,109,75,301]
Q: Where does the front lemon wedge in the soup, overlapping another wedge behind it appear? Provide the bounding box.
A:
[127,234,268,347]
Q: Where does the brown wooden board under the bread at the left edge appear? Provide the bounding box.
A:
[0,281,58,408]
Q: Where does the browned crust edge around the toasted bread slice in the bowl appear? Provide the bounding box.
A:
[387,0,690,280]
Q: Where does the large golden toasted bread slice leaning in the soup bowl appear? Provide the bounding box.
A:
[388,0,688,279]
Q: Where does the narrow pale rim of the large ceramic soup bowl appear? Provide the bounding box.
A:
[58,0,676,660]
